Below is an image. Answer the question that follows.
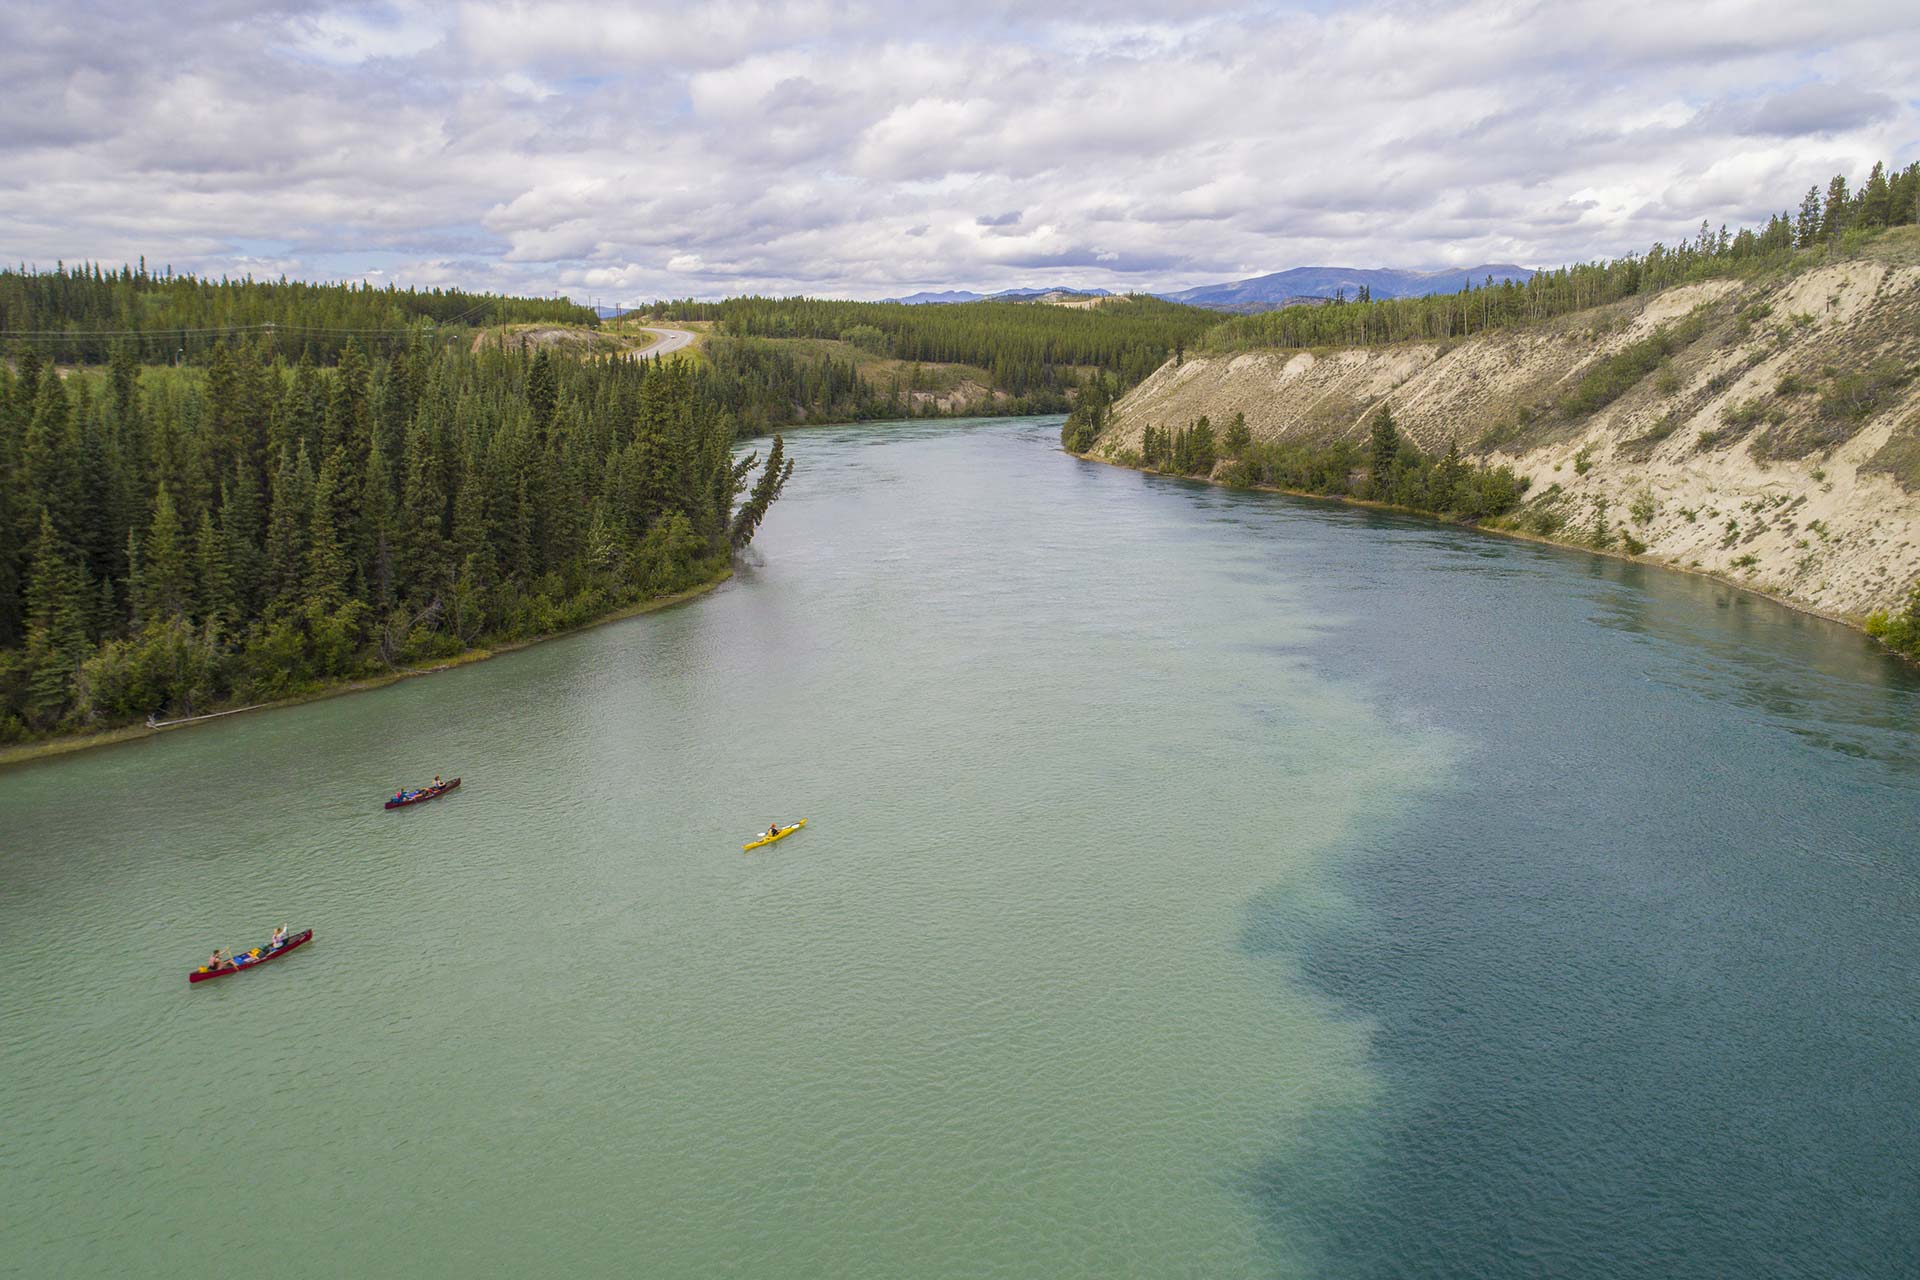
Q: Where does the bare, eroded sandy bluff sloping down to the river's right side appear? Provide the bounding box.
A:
[1091,239,1920,626]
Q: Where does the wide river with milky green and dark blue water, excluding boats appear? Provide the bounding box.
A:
[0,418,1920,1280]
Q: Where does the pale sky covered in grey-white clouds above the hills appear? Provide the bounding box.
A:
[0,0,1920,301]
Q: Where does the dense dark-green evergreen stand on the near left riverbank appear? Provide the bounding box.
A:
[0,335,793,741]
